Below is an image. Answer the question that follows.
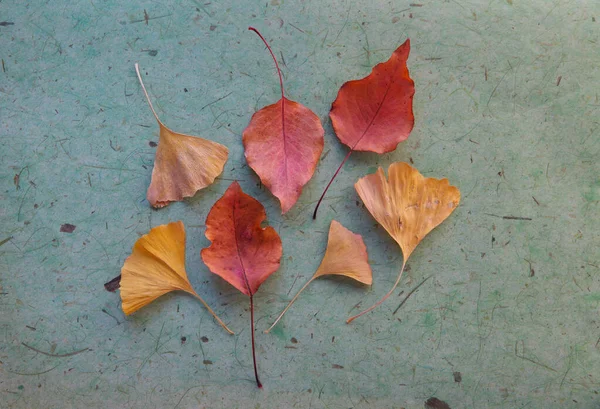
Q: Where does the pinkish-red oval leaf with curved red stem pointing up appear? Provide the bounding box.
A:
[243,27,325,213]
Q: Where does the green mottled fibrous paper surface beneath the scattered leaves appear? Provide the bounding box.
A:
[0,0,600,409]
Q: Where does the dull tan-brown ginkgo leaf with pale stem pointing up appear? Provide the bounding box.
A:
[135,63,229,208]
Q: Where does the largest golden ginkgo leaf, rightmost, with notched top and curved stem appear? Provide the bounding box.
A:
[347,162,460,323]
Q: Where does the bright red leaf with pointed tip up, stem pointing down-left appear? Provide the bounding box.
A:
[313,40,415,219]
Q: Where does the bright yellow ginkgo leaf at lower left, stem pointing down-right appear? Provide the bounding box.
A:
[116,221,233,334]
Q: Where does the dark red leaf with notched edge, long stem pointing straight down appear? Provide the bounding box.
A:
[201,182,283,388]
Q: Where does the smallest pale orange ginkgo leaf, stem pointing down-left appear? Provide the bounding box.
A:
[265,220,373,333]
